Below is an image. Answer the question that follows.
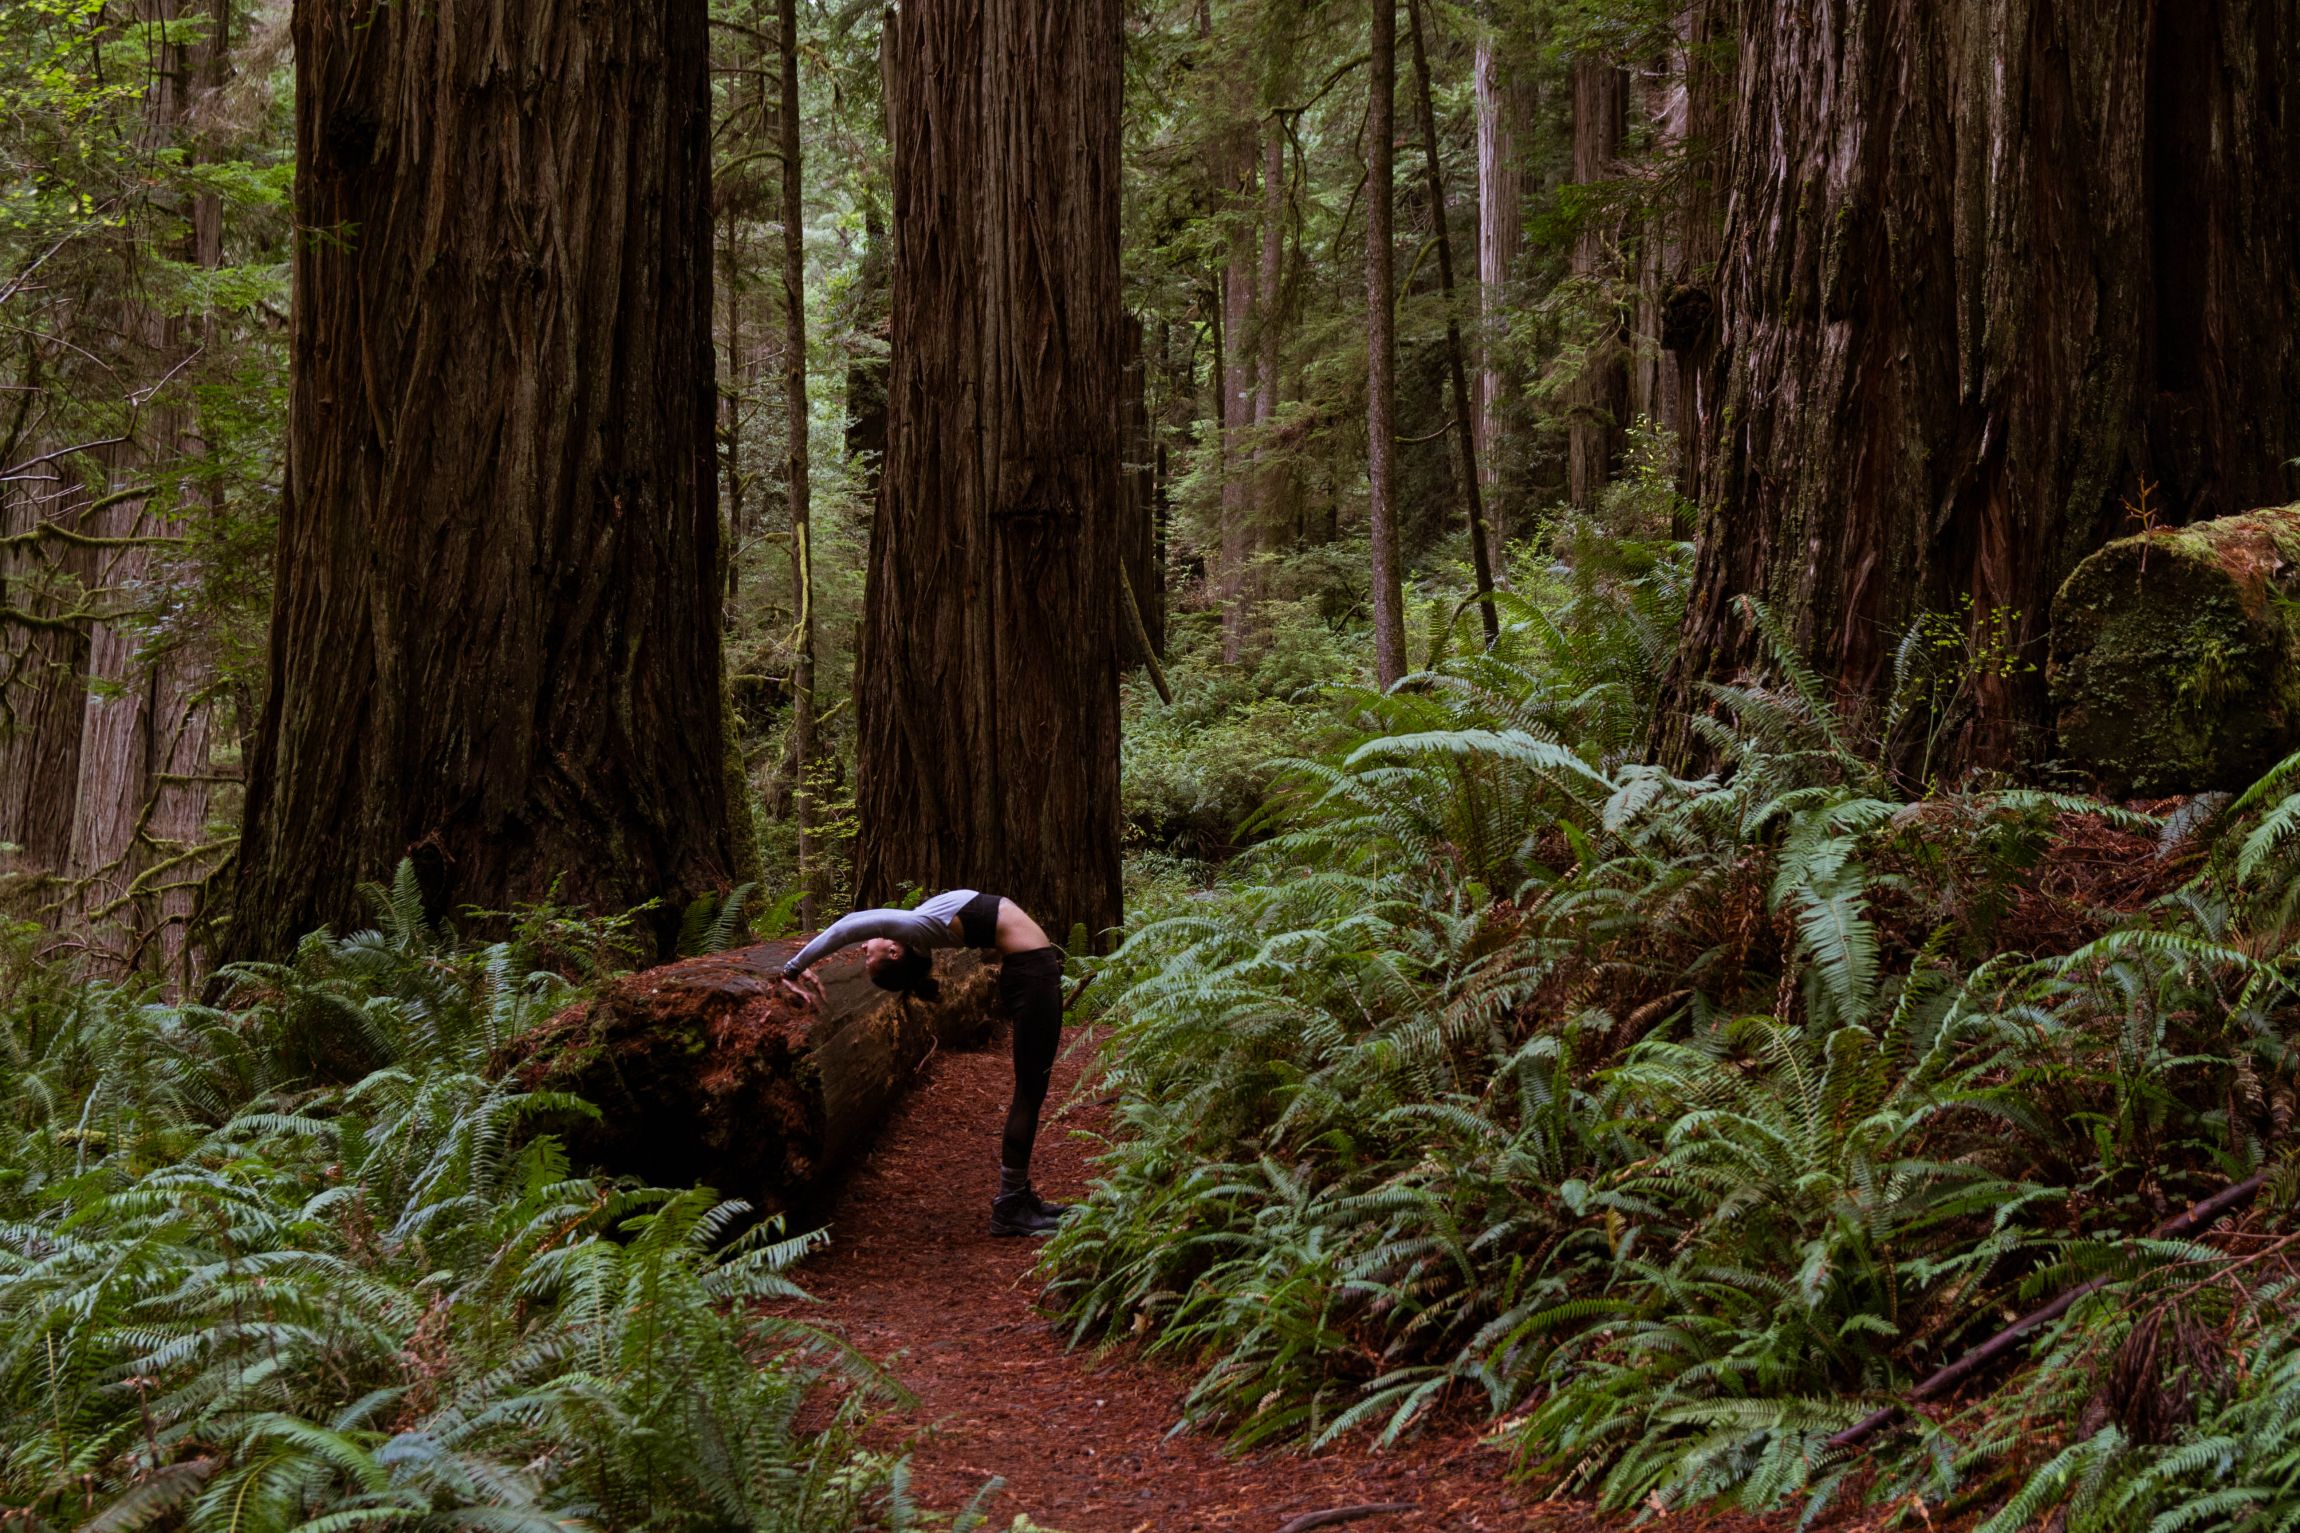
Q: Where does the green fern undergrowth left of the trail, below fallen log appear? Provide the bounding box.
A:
[0,878,1002,1533]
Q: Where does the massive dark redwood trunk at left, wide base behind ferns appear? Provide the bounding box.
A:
[225,0,745,956]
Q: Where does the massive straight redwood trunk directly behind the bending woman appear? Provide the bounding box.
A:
[856,0,1122,935]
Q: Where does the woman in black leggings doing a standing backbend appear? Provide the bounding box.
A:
[782,889,1070,1234]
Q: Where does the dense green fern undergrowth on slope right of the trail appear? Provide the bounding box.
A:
[1047,547,2300,1533]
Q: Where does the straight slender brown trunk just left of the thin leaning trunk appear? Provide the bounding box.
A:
[1366,0,1405,687]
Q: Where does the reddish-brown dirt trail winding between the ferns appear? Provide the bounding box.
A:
[794,1037,1554,1533]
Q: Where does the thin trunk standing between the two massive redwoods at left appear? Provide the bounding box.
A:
[782,0,823,926]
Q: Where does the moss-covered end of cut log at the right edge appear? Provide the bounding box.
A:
[2047,506,2300,793]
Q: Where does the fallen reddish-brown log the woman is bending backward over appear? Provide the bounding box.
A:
[504,940,998,1218]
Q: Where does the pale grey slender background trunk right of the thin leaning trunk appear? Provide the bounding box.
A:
[1474,25,1534,584]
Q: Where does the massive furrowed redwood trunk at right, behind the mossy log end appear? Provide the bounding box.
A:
[1663,0,2300,763]
